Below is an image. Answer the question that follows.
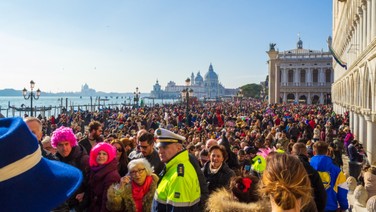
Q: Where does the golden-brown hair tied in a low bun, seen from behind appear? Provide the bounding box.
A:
[259,153,312,210]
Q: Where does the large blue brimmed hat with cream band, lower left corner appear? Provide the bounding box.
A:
[0,118,82,211]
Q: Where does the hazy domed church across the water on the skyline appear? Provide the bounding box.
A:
[151,64,236,99]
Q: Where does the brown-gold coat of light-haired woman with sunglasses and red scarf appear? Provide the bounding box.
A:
[107,174,159,212]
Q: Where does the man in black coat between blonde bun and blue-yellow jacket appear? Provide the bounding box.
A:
[291,142,327,212]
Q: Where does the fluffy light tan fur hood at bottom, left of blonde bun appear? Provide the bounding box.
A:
[206,188,271,212]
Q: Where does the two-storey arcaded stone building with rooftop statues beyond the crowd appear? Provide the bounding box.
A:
[267,38,333,104]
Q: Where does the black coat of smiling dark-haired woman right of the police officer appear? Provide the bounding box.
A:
[202,161,235,193]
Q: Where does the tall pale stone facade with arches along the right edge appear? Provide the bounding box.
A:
[332,0,376,162]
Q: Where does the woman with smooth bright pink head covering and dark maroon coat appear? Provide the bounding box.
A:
[88,142,120,212]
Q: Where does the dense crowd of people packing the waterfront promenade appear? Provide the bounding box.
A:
[2,99,376,211]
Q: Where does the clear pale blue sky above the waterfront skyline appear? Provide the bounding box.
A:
[0,0,332,93]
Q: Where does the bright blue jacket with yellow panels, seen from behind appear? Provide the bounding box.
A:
[310,155,349,211]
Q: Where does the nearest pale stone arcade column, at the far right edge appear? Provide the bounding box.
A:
[364,115,376,163]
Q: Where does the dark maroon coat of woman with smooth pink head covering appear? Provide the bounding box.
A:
[88,159,120,212]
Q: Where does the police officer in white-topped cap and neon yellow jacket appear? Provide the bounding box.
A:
[153,128,201,211]
